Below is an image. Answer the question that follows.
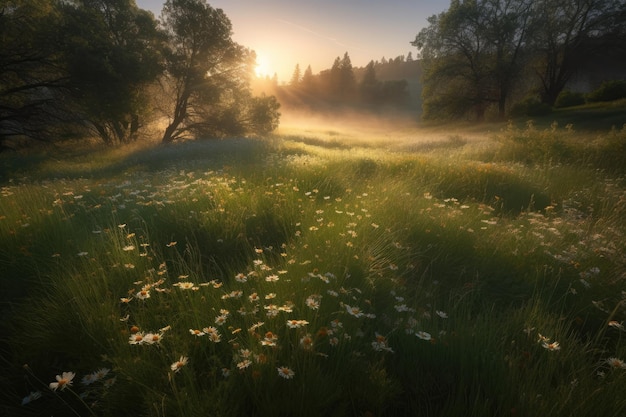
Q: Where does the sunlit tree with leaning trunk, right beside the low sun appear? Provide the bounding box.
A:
[161,0,278,143]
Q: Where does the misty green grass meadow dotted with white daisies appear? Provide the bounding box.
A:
[0,102,626,417]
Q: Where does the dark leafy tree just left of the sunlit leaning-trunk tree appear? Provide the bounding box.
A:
[62,0,162,143]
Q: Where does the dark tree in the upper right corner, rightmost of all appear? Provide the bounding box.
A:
[532,0,626,106]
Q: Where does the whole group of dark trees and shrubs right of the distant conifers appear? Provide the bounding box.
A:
[412,0,626,120]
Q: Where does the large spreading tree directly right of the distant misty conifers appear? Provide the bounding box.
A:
[412,0,532,120]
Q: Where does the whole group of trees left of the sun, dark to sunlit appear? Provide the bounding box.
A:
[0,0,279,147]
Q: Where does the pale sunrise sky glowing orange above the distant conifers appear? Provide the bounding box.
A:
[135,0,450,82]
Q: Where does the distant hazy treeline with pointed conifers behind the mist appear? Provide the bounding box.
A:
[250,52,420,112]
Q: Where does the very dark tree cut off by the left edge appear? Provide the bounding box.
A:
[0,0,67,149]
